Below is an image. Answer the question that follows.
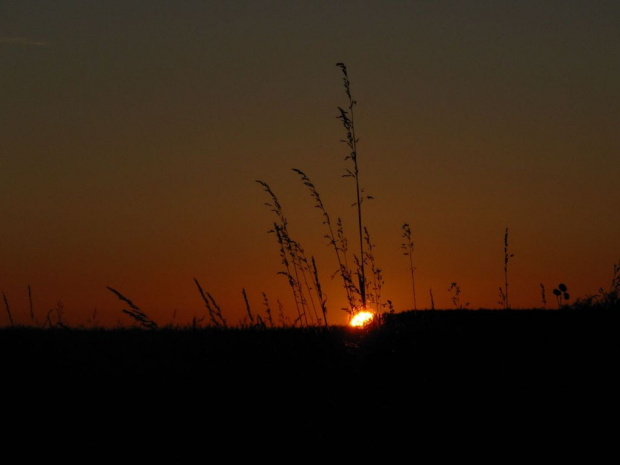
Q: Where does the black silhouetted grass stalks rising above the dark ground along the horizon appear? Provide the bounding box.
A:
[2,62,620,330]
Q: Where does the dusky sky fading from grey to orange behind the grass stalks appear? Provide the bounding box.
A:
[0,0,620,327]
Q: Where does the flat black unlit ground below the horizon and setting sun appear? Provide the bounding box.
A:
[0,310,620,456]
